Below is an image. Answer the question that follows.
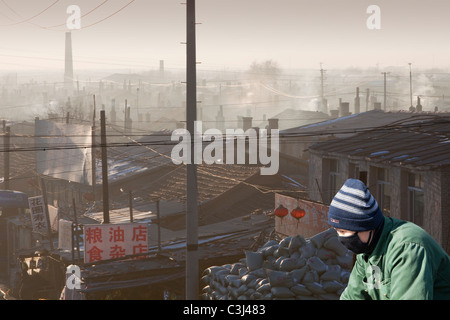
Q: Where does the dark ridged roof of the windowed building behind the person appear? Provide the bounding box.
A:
[310,116,450,169]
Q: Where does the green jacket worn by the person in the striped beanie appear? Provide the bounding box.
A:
[341,217,450,300]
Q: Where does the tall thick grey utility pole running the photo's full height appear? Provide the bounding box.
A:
[186,0,199,300]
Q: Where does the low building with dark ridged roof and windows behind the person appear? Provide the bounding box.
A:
[309,115,450,252]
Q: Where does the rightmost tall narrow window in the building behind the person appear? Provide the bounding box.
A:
[408,173,424,226]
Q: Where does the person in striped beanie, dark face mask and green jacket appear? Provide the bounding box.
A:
[328,179,450,300]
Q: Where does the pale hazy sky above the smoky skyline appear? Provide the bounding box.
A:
[0,0,450,71]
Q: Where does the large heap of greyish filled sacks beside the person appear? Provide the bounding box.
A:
[202,228,353,300]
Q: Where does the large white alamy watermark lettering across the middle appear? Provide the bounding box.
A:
[171,121,280,175]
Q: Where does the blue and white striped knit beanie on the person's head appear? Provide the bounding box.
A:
[328,179,384,232]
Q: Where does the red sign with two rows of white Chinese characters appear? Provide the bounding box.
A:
[84,223,148,263]
